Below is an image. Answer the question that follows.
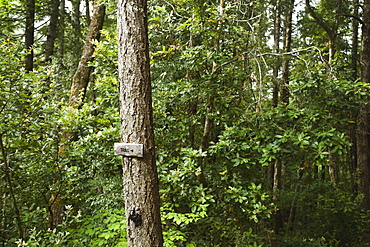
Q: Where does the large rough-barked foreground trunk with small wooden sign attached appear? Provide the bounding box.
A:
[117,0,163,247]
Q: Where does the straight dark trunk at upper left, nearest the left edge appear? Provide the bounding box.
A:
[24,0,35,71]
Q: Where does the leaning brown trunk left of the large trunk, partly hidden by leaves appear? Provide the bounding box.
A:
[49,3,105,228]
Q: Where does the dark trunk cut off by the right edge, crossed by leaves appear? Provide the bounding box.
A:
[357,0,370,210]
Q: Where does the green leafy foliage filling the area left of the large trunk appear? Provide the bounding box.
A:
[0,33,126,246]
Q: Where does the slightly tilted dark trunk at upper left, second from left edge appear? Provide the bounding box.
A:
[45,0,60,62]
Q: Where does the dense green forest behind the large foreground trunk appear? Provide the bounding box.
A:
[0,0,370,247]
